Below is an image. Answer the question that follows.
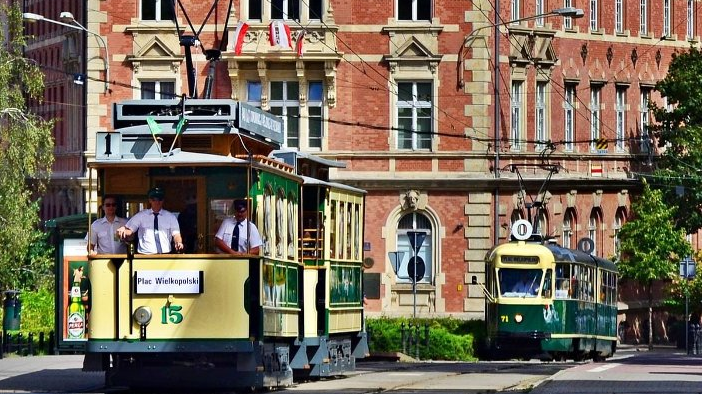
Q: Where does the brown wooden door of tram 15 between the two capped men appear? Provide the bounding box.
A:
[154,177,210,253]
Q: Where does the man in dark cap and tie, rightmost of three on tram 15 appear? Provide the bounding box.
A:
[215,200,263,255]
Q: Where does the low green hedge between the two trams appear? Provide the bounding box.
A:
[366,317,484,361]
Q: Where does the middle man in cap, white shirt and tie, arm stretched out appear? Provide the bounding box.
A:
[117,187,183,254]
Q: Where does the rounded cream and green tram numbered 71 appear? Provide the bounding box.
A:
[484,235,617,360]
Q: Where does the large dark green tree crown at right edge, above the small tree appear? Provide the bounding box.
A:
[650,47,702,234]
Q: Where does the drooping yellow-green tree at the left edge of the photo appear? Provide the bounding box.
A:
[0,2,53,289]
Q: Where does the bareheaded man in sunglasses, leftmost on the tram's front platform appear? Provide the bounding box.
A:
[85,196,127,256]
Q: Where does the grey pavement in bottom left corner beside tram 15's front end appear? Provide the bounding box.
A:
[0,355,105,393]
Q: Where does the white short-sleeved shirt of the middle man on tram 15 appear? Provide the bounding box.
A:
[126,208,180,254]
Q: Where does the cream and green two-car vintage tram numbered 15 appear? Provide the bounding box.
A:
[85,99,368,389]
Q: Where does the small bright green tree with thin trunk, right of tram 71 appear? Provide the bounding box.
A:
[618,181,692,347]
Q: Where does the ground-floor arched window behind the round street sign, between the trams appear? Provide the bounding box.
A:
[397,212,433,283]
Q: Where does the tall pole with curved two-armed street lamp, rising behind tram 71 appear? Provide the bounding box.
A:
[457,6,585,243]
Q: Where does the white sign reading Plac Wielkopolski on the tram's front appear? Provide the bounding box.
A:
[134,271,205,294]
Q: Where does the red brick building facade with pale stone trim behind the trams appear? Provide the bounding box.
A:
[26,0,702,330]
